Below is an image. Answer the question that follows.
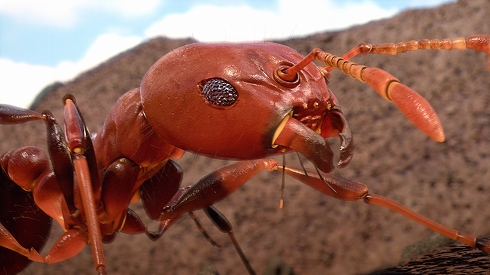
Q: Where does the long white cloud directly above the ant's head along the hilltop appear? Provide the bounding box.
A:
[145,0,397,42]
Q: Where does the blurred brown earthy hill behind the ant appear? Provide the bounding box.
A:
[0,0,490,274]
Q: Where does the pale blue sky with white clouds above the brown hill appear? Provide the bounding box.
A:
[0,0,453,107]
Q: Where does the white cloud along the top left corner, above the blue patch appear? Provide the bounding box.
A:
[0,0,160,28]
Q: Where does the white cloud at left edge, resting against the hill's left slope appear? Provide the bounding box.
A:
[0,34,142,108]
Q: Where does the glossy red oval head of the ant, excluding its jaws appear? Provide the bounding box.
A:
[141,42,350,171]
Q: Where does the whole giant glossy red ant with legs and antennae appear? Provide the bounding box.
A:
[0,35,490,274]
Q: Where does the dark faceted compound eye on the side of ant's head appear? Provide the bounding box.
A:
[202,78,238,106]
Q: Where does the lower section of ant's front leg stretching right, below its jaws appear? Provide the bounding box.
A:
[277,166,490,253]
